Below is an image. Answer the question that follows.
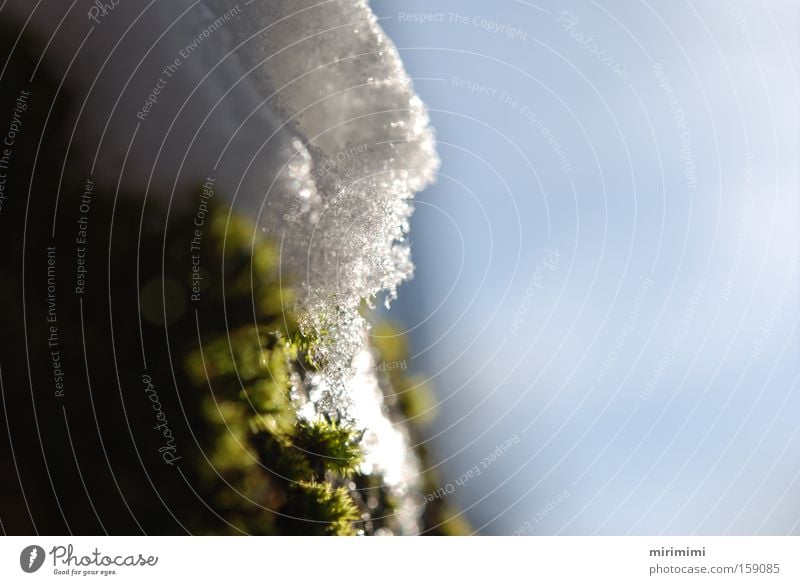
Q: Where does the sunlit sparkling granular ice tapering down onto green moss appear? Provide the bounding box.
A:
[212,0,438,414]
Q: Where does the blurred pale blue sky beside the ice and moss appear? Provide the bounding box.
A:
[372,0,800,534]
